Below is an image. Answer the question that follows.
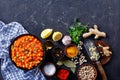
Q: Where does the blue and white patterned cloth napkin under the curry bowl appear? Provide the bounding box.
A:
[0,21,46,80]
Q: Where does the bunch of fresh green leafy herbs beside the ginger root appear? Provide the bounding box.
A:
[68,19,88,44]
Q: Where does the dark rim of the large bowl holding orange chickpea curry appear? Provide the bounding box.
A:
[9,34,45,70]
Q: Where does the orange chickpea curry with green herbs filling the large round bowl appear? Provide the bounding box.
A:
[10,35,44,69]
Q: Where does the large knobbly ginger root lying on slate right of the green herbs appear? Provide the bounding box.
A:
[83,25,106,39]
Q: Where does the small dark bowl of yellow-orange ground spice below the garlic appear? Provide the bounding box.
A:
[65,44,79,58]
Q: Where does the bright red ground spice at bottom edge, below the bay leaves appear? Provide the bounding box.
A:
[57,69,70,80]
